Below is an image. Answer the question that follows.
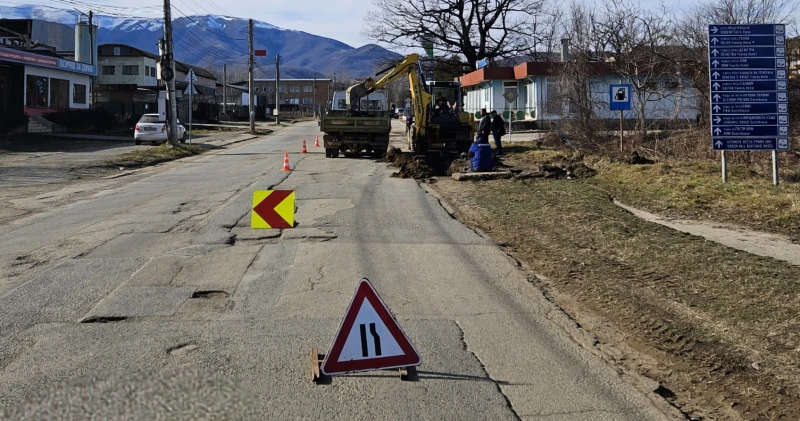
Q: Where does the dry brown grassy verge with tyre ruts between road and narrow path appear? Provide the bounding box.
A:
[433,179,800,419]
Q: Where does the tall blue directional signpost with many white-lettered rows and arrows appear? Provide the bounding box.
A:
[708,25,790,185]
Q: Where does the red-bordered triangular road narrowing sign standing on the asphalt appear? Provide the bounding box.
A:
[321,278,422,376]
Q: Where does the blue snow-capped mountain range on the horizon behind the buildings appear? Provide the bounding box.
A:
[0,6,400,78]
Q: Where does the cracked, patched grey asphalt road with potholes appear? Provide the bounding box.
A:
[0,123,675,420]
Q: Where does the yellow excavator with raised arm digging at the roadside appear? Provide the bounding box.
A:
[345,54,475,154]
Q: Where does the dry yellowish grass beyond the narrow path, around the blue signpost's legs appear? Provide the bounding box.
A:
[506,143,800,240]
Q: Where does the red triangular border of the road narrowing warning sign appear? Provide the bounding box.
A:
[320,278,422,376]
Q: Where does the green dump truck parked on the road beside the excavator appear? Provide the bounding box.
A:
[319,91,392,158]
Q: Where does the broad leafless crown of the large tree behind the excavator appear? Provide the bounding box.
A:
[365,0,544,69]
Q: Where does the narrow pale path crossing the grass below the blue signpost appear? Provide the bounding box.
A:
[614,200,800,266]
